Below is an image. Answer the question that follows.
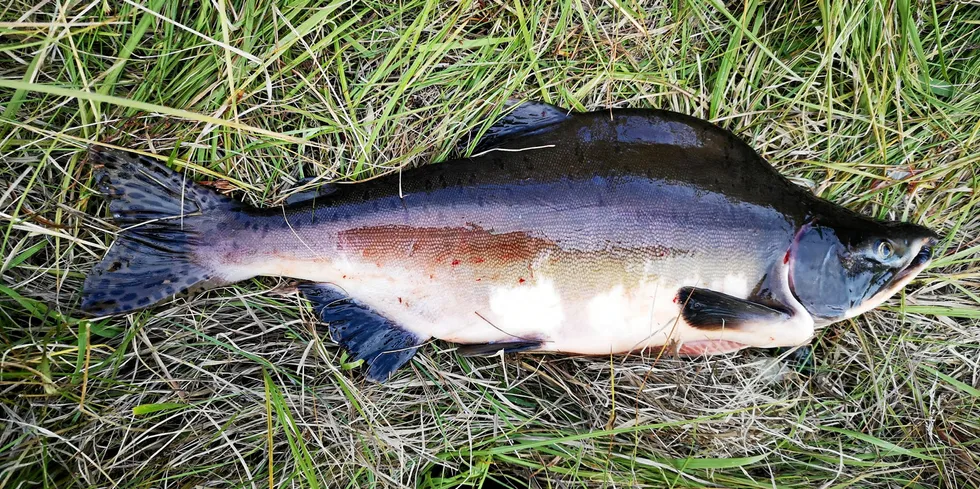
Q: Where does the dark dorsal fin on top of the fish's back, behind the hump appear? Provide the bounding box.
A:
[456,99,570,154]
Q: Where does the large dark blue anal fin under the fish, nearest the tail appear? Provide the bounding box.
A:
[299,284,426,382]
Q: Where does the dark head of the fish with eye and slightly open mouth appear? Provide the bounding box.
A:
[784,215,939,326]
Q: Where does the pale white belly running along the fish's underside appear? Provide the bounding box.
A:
[239,260,813,355]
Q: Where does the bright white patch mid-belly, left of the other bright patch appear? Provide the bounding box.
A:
[487,277,565,337]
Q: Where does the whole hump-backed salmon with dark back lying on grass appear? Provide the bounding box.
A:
[80,102,940,382]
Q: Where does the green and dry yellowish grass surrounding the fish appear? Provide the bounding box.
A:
[0,0,980,488]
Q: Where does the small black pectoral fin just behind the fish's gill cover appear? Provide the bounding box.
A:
[675,287,791,330]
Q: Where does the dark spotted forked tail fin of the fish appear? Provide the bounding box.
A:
[82,147,239,316]
